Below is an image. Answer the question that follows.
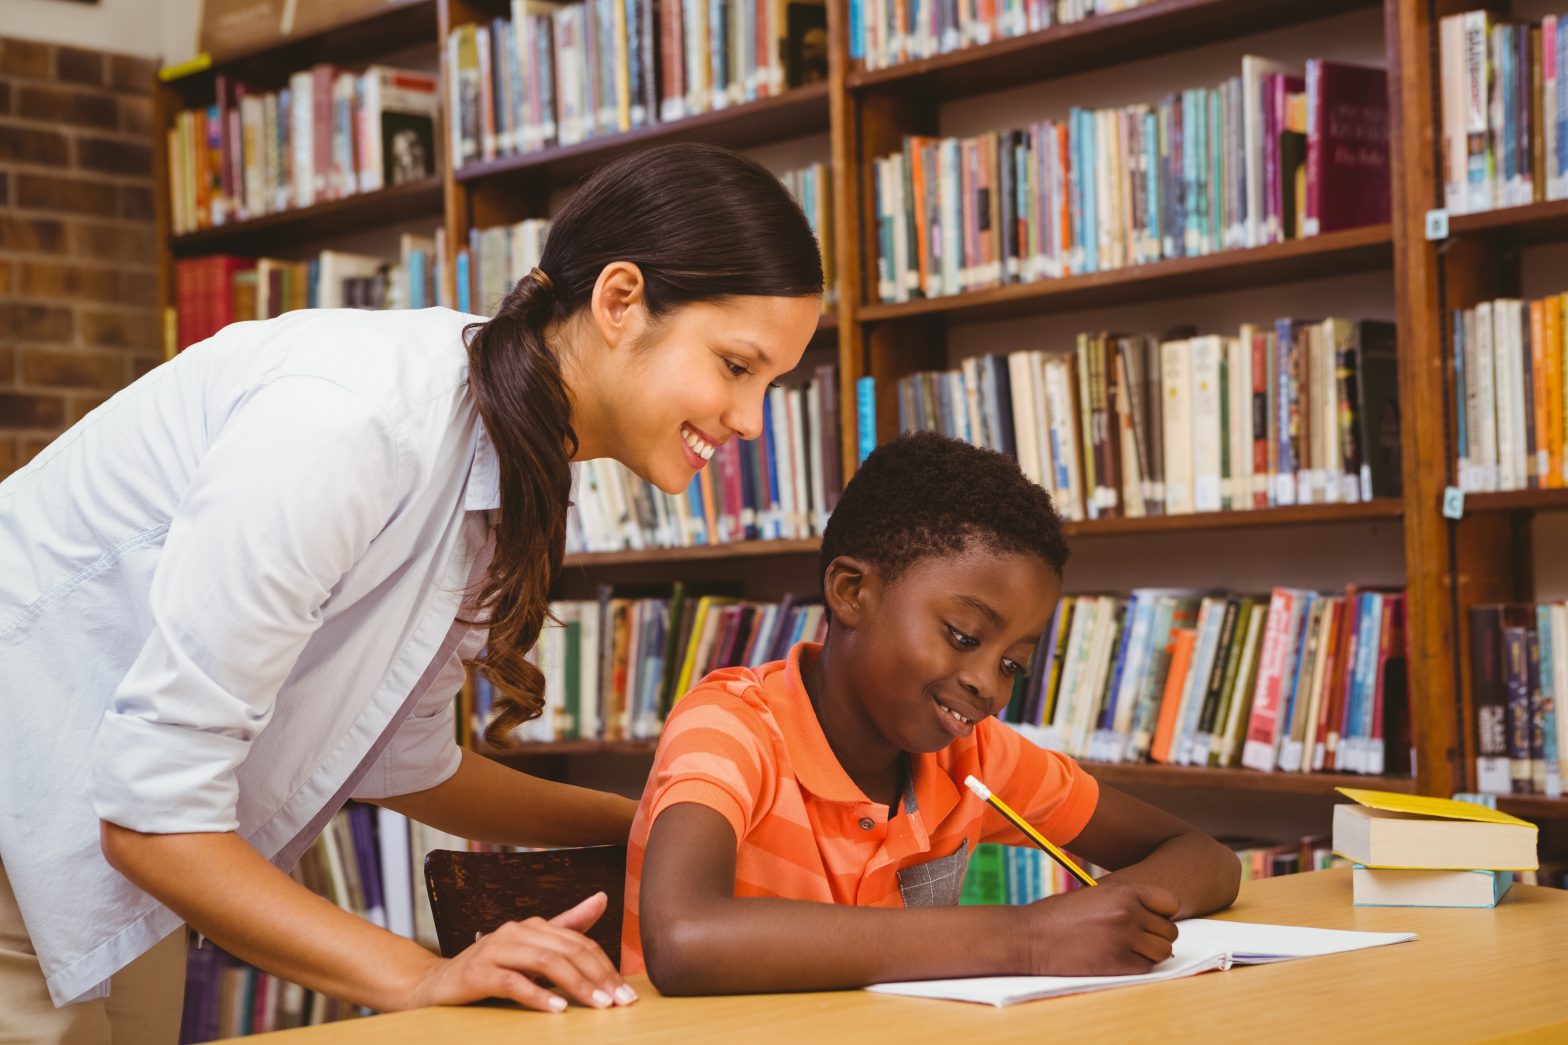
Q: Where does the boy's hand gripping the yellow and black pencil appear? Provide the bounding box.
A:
[1022,880,1178,976]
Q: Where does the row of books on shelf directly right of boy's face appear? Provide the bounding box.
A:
[1004,587,1410,775]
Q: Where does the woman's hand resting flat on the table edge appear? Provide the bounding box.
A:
[408,893,637,1012]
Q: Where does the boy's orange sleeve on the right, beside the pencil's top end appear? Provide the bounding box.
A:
[980,720,1099,846]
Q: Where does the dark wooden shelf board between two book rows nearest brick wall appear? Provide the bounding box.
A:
[172,176,442,257]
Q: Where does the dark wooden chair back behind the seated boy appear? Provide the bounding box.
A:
[425,846,626,968]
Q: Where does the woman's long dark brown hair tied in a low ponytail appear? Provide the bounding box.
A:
[464,144,822,745]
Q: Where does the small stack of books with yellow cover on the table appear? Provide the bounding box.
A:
[1334,788,1538,907]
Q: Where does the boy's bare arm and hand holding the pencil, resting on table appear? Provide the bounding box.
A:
[640,803,1176,995]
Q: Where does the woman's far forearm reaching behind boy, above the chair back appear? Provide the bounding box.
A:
[375,748,637,846]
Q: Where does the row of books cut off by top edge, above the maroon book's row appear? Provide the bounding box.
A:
[850,0,1149,69]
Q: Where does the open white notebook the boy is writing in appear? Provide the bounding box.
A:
[867,918,1416,1006]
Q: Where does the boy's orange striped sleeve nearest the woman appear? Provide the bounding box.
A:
[643,679,778,847]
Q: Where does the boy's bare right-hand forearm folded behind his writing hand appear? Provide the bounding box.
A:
[1073,785,1242,918]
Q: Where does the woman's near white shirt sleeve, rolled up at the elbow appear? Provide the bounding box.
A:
[91,377,411,833]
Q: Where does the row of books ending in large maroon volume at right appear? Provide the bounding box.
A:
[873,56,1389,301]
